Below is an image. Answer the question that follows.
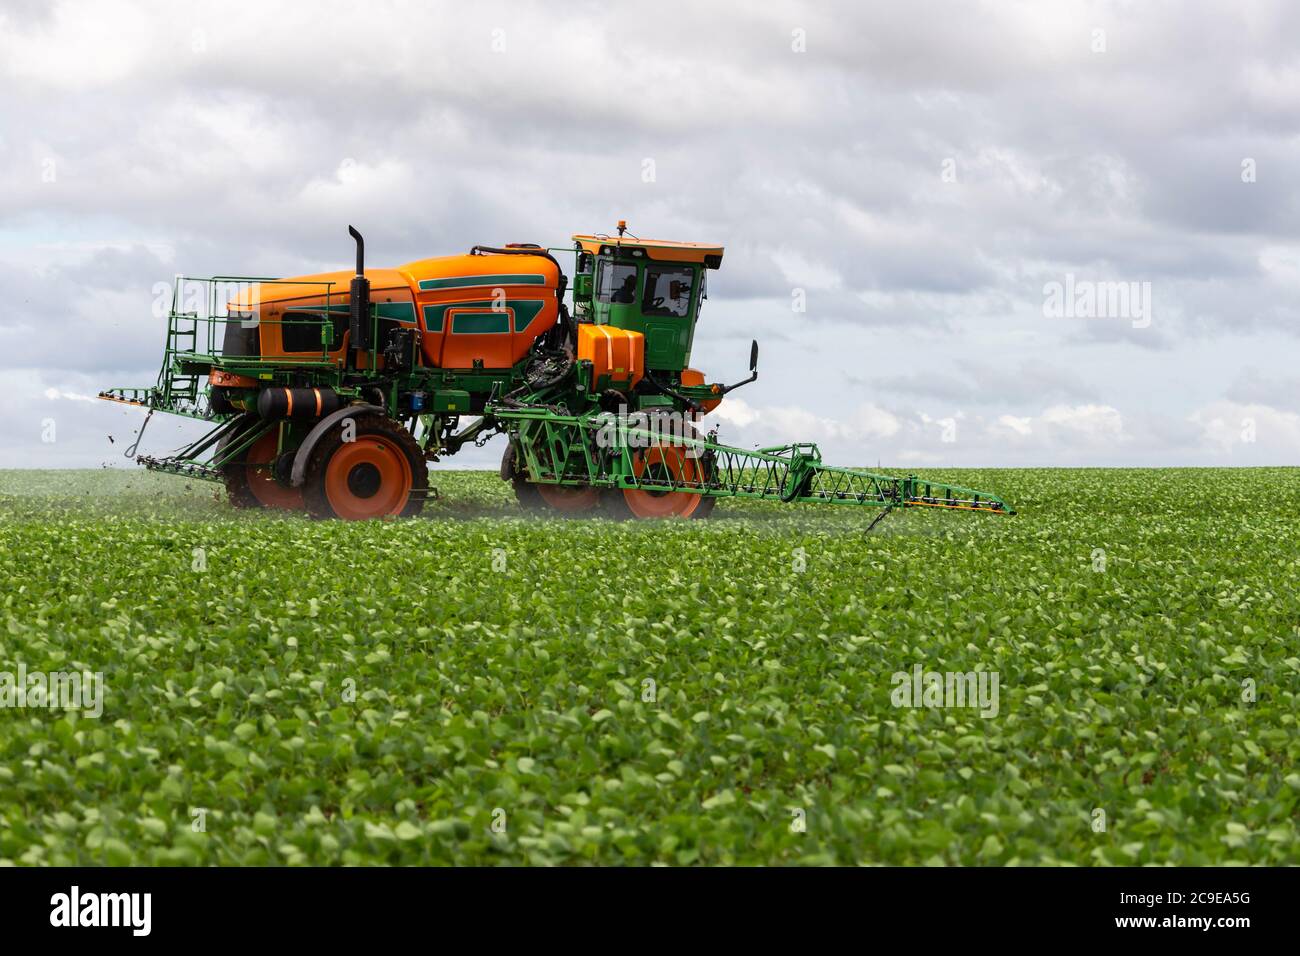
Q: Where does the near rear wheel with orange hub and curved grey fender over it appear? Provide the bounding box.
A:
[303,412,429,520]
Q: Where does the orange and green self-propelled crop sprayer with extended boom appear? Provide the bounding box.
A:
[100,222,1013,519]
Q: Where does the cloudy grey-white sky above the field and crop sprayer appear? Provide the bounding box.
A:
[0,0,1300,467]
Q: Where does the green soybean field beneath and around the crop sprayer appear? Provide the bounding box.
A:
[0,468,1300,866]
